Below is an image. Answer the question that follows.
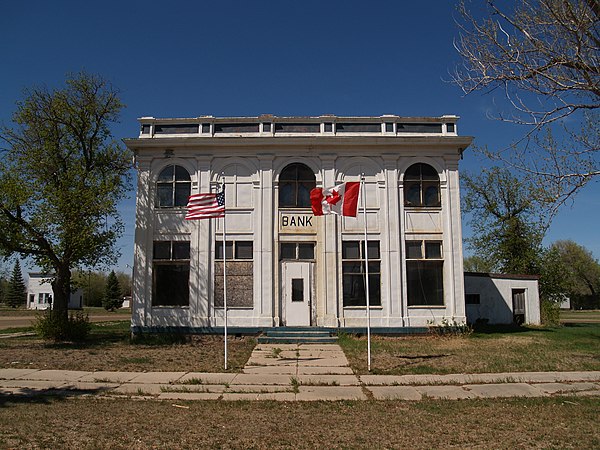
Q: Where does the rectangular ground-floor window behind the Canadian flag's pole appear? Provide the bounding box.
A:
[342,241,381,307]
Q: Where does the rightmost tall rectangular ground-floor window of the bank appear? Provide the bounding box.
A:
[406,241,444,306]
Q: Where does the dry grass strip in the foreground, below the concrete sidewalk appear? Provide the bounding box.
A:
[0,397,600,449]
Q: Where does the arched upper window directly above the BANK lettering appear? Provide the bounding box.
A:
[279,163,317,208]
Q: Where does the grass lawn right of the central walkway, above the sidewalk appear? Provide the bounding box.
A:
[338,324,600,375]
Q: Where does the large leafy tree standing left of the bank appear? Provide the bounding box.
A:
[0,72,131,334]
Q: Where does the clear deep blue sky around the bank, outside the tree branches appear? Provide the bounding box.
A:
[0,0,600,271]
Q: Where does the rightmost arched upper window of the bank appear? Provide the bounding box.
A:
[404,163,441,207]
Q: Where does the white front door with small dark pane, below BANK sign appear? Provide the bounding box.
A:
[281,261,312,326]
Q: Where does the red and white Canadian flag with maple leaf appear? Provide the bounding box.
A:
[310,181,360,217]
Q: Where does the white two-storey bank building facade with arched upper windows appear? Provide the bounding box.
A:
[125,115,472,332]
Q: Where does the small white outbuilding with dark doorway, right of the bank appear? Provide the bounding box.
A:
[465,272,541,325]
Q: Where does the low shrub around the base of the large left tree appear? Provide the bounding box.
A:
[33,309,91,342]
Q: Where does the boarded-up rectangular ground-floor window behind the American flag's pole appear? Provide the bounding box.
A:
[214,241,254,308]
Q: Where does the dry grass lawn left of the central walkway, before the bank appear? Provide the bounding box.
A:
[0,322,256,372]
